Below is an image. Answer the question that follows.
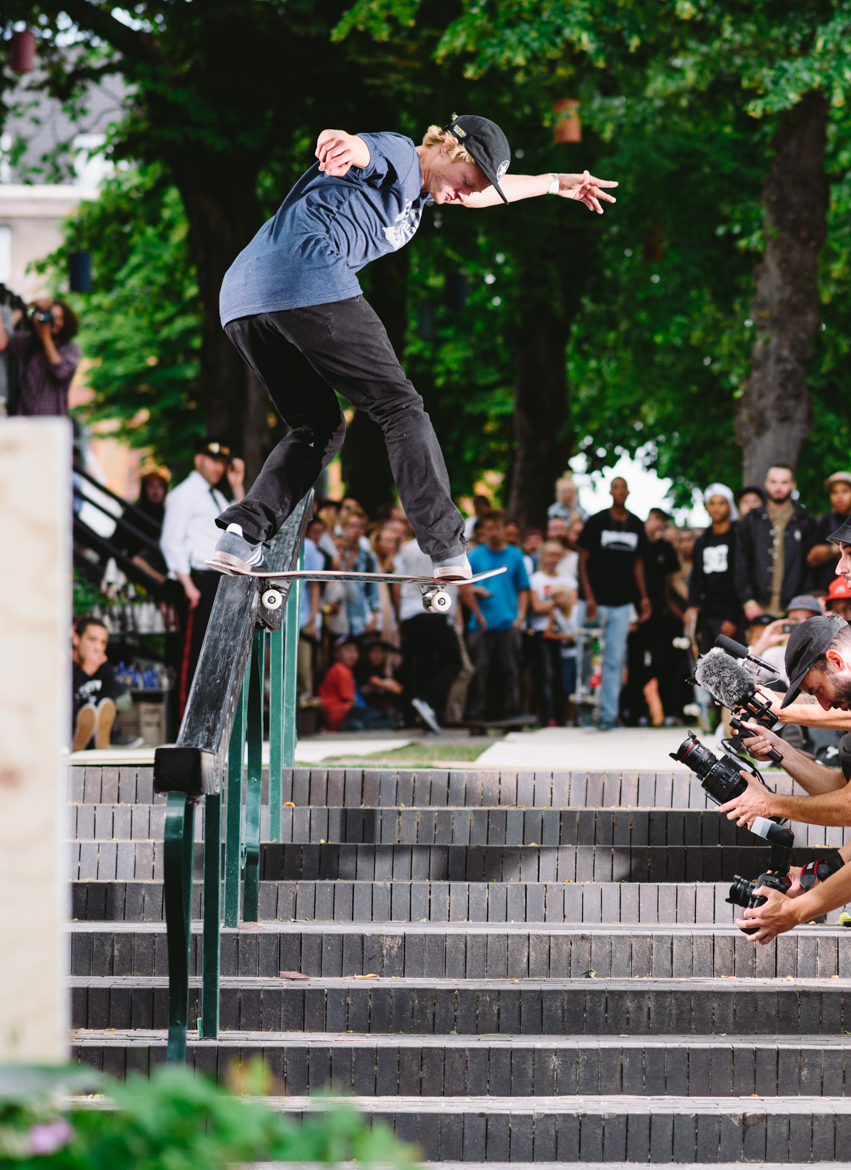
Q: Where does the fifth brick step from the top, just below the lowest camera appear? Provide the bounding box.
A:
[70,922,851,982]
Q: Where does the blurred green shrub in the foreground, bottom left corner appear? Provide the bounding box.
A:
[0,1064,413,1170]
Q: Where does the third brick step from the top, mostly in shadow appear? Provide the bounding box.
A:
[69,838,826,885]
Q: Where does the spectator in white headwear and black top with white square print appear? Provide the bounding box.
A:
[685,483,742,654]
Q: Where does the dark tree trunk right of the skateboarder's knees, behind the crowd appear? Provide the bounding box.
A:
[508,302,571,529]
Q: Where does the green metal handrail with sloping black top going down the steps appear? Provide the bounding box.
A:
[155,493,313,1064]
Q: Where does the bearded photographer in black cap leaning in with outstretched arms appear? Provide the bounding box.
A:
[720,614,851,827]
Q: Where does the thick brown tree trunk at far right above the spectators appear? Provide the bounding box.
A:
[736,91,829,483]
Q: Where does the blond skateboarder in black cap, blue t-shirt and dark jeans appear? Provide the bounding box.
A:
[214,115,617,579]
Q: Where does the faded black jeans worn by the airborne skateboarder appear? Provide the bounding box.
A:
[217,296,467,560]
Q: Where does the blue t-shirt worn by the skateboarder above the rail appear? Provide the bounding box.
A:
[219,132,430,325]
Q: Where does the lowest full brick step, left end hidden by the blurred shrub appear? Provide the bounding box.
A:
[66,1076,851,1166]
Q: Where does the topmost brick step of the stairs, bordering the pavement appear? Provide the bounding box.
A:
[68,762,805,808]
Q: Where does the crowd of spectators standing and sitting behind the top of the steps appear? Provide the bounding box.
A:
[73,430,851,735]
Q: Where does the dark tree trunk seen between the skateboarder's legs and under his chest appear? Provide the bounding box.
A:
[341,248,411,517]
